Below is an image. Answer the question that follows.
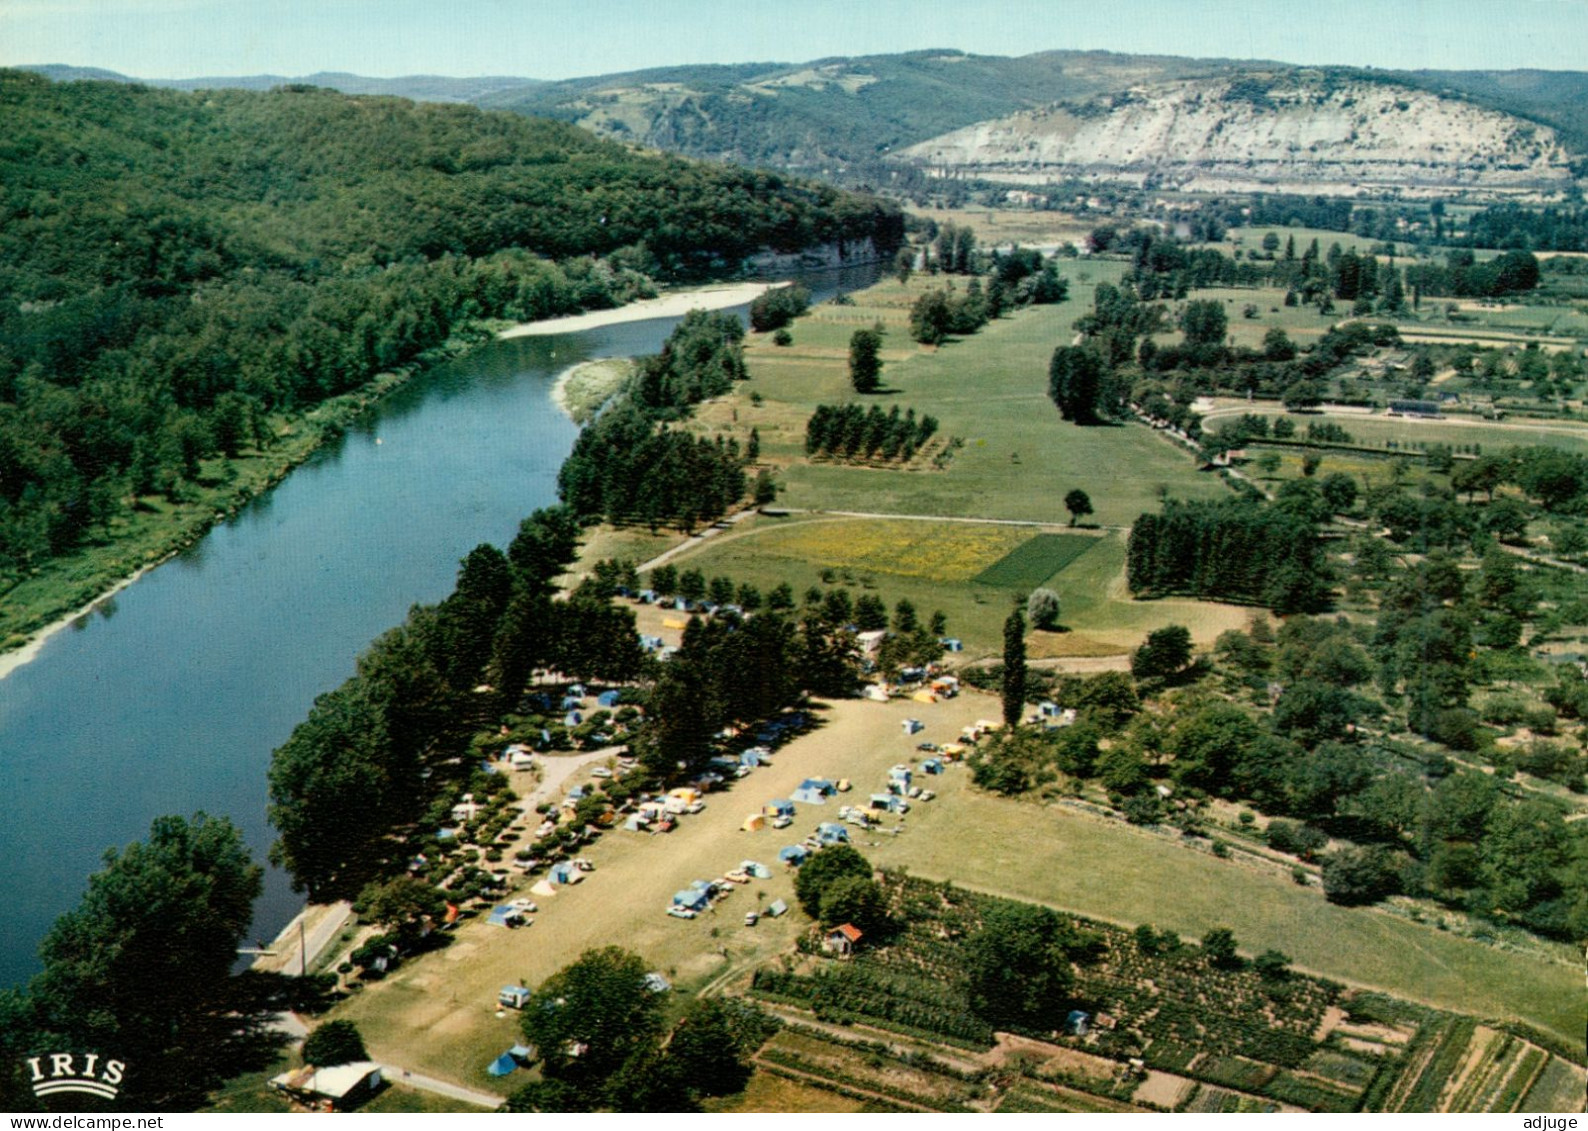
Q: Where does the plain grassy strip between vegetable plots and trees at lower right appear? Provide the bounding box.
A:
[872,756,1582,1040]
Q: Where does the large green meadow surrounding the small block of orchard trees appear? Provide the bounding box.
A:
[717,264,1221,526]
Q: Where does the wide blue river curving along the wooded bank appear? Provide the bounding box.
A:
[0,267,878,986]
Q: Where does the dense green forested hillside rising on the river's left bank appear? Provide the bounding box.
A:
[0,71,902,591]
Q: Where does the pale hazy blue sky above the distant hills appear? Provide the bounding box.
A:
[0,0,1588,78]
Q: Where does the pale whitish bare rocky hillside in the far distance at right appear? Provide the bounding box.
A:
[899,75,1572,194]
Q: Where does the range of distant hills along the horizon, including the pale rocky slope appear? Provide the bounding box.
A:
[30,49,1588,192]
